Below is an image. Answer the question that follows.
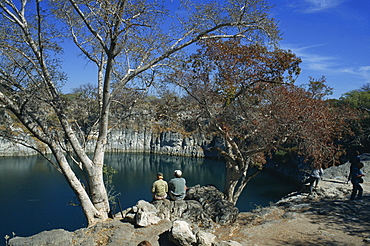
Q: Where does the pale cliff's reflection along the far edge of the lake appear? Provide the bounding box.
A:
[0,153,225,189]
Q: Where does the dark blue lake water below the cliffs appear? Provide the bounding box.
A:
[0,153,296,245]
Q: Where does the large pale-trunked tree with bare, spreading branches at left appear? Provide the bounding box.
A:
[0,0,278,225]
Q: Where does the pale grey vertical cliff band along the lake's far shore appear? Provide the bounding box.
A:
[0,129,220,157]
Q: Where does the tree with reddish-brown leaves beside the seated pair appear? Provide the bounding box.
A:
[173,39,352,203]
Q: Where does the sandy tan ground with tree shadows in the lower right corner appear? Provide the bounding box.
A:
[216,180,370,246]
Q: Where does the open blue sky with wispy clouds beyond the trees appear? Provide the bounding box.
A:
[63,0,370,98]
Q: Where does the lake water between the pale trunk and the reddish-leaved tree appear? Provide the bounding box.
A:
[106,153,225,207]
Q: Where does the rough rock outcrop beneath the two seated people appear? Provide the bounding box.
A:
[128,185,239,227]
